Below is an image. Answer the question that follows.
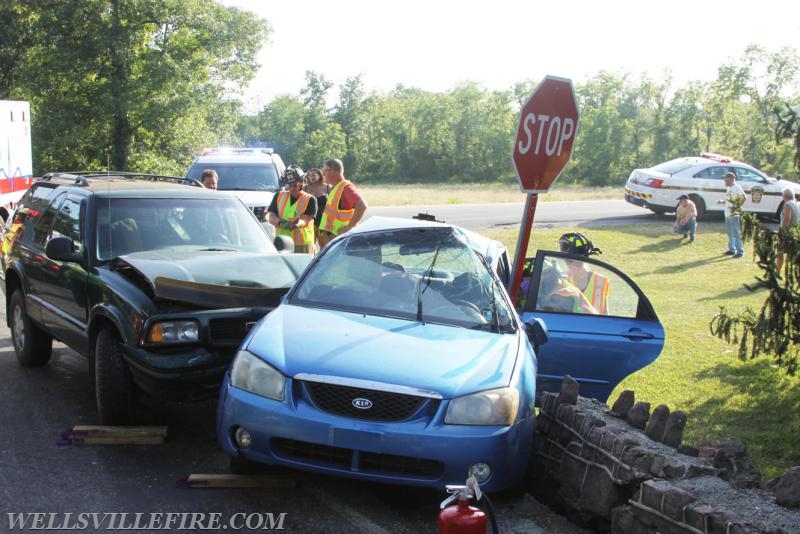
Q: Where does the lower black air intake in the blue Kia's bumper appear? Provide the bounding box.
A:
[271,438,444,479]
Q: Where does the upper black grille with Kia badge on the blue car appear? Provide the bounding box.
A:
[303,382,428,421]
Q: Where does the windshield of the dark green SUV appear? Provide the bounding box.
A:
[96,198,276,260]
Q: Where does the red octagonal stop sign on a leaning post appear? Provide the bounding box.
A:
[512,76,579,193]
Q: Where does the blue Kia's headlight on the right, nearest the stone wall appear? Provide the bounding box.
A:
[444,388,519,425]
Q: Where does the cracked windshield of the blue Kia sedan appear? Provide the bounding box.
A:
[290,227,516,333]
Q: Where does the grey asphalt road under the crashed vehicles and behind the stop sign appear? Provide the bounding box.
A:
[0,201,612,534]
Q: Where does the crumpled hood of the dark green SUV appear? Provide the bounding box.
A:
[118,249,299,308]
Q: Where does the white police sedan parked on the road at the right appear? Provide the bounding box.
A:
[625,152,800,219]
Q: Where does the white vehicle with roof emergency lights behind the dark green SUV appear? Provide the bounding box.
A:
[186,147,286,221]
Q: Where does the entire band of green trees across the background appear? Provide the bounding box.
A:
[0,0,800,186]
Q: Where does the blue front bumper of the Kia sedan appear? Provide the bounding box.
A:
[217,377,535,491]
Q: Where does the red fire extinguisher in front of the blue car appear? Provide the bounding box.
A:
[439,477,499,534]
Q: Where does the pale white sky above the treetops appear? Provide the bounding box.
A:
[222,0,800,108]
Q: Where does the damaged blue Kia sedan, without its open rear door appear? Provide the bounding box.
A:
[217,217,536,491]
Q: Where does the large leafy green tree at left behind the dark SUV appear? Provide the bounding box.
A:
[7,0,268,173]
